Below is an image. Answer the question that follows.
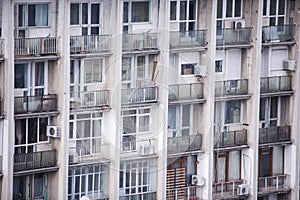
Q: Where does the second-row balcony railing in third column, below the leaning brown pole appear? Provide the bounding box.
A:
[121,86,158,104]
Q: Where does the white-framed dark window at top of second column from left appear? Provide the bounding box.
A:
[70,3,102,35]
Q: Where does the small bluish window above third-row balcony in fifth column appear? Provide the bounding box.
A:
[225,100,242,124]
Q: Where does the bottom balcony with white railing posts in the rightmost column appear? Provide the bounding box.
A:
[258,175,291,194]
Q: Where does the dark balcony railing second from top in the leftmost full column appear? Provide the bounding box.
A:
[15,94,57,114]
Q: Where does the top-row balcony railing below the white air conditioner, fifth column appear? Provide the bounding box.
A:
[216,27,251,46]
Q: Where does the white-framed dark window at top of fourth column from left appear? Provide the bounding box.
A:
[170,0,196,32]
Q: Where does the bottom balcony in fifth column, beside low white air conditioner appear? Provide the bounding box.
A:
[212,180,243,199]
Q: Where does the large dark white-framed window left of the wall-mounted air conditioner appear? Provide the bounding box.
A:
[15,117,50,154]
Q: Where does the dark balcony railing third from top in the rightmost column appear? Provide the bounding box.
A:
[259,126,291,144]
